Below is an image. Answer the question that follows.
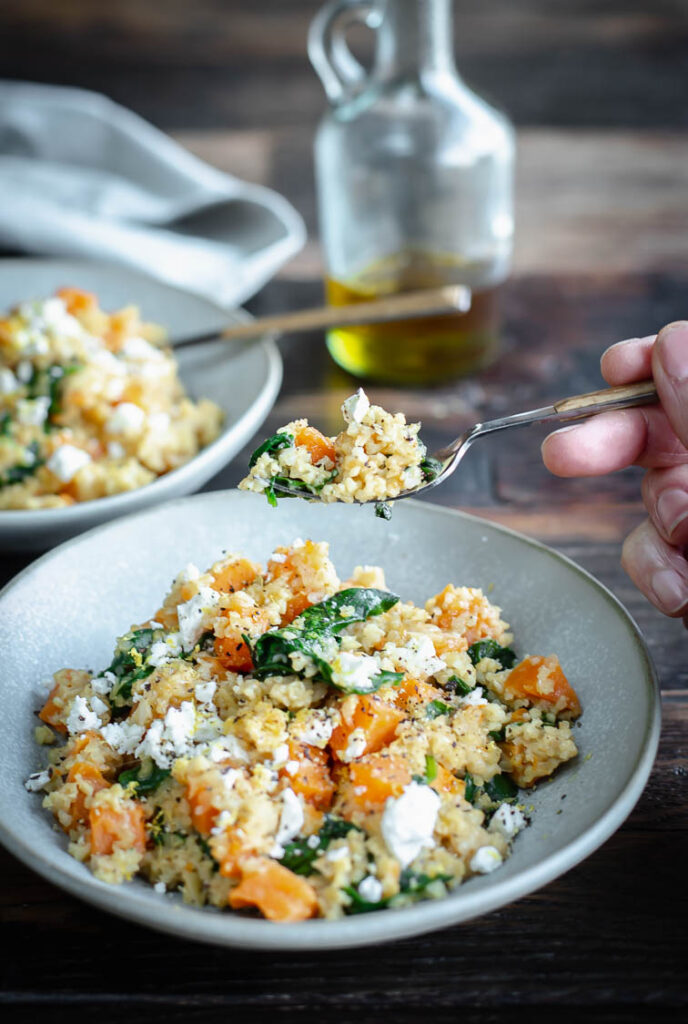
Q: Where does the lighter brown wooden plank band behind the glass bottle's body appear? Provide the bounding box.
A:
[175,128,688,280]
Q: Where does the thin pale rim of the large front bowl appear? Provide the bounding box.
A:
[0,488,661,951]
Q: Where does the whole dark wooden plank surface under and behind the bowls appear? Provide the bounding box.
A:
[0,0,688,1024]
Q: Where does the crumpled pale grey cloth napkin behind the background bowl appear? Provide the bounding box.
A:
[0,82,305,306]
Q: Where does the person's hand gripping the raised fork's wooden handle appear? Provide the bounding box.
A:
[543,321,688,626]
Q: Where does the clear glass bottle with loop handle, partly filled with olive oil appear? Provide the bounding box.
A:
[308,0,515,385]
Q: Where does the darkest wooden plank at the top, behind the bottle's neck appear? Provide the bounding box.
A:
[0,0,688,129]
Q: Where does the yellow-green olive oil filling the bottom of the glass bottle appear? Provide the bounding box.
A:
[326,253,499,385]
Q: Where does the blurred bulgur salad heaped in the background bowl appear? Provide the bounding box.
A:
[0,288,222,509]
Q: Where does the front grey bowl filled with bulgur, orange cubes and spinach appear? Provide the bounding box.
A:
[0,492,658,949]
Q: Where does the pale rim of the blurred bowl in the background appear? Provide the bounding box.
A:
[0,256,283,536]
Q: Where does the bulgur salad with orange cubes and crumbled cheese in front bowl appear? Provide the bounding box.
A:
[26,540,581,922]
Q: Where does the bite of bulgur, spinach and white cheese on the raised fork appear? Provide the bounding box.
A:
[239,388,429,504]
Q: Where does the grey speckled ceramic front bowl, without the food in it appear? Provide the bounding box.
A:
[0,492,659,950]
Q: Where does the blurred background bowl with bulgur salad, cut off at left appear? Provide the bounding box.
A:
[0,260,280,547]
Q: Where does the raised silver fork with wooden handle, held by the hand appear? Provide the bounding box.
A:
[274,380,657,505]
